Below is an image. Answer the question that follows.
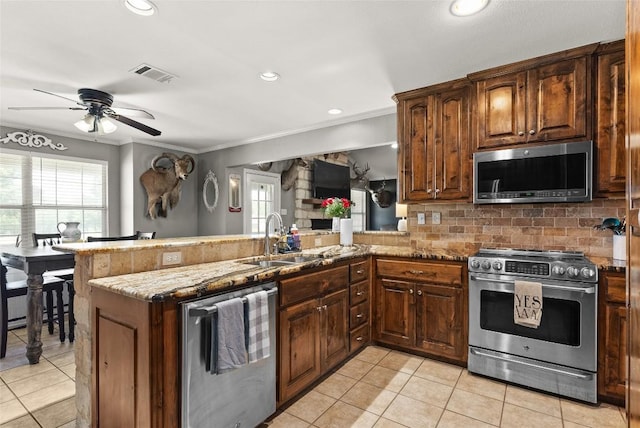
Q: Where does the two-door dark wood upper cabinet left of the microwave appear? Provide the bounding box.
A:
[395,79,470,202]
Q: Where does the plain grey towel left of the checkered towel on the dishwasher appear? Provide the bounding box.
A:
[216,298,247,373]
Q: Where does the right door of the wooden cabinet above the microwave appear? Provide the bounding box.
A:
[526,57,587,142]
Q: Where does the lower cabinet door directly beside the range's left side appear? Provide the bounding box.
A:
[416,285,464,358]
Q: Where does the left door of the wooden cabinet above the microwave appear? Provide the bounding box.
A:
[476,72,527,149]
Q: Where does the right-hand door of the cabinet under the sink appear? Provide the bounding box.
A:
[320,289,349,371]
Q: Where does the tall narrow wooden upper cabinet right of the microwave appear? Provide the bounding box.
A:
[594,40,626,196]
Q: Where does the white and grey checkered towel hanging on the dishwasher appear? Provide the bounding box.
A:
[245,291,271,363]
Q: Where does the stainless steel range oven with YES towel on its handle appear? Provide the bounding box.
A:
[468,249,598,403]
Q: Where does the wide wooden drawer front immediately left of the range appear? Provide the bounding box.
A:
[376,259,462,287]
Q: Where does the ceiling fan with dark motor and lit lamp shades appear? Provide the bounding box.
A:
[9,88,160,137]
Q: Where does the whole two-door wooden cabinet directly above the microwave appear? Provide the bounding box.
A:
[469,45,597,150]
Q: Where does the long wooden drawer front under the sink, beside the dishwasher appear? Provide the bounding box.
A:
[279,266,349,306]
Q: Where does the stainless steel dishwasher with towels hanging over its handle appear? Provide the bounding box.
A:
[180,282,278,428]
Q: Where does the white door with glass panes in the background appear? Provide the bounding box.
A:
[243,169,280,234]
